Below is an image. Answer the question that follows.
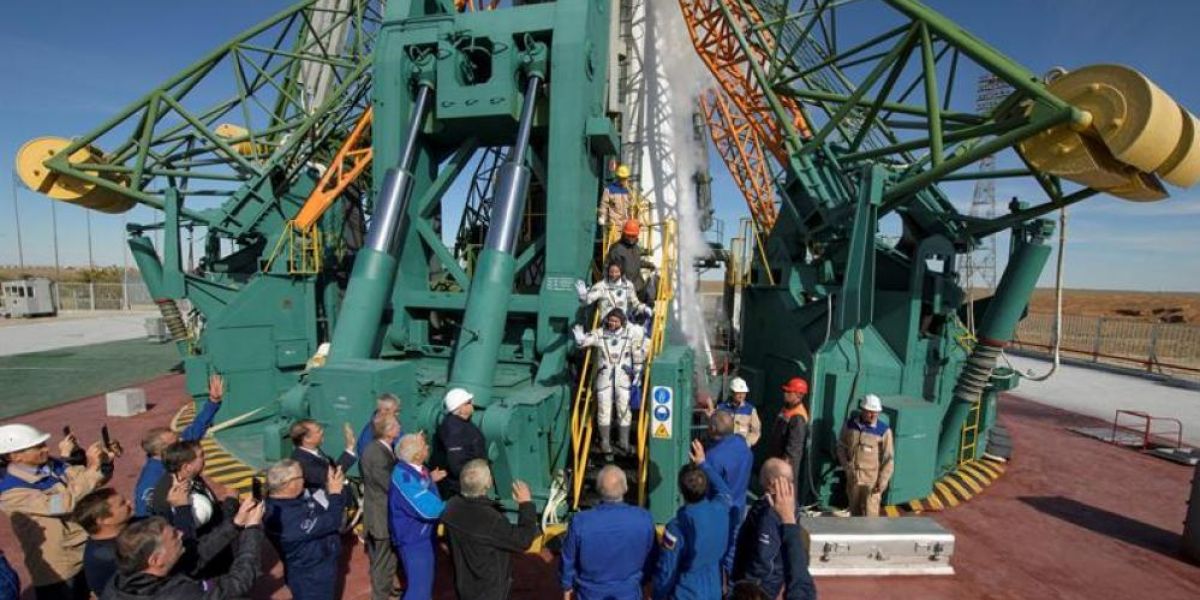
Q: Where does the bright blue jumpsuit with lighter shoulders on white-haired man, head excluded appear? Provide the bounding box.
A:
[388,462,445,600]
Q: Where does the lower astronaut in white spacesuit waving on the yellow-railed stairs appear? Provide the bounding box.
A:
[571,308,646,455]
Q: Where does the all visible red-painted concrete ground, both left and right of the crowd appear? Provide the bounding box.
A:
[0,376,1200,600]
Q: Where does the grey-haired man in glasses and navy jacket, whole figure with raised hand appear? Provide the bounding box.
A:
[263,458,346,600]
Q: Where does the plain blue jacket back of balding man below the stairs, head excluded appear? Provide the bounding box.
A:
[559,502,654,600]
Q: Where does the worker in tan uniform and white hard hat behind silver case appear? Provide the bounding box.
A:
[838,394,895,517]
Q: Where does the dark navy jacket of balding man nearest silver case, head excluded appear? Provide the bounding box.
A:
[731,496,817,599]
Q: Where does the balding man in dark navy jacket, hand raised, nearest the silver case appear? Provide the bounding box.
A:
[730,458,817,599]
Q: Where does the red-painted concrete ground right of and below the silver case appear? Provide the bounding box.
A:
[817,396,1200,600]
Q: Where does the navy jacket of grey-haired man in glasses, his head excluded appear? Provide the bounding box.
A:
[263,491,346,600]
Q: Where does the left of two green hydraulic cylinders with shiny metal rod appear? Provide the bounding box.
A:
[329,84,432,362]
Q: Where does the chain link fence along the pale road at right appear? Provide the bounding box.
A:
[1014,313,1200,378]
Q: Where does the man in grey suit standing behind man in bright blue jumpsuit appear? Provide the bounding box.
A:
[359,414,401,600]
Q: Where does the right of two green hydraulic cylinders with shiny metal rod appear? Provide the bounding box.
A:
[450,76,541,407]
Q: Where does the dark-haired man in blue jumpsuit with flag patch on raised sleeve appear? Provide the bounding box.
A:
[654,440,733,600]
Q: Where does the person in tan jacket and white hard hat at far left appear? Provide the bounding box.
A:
[0,424,112,600]
